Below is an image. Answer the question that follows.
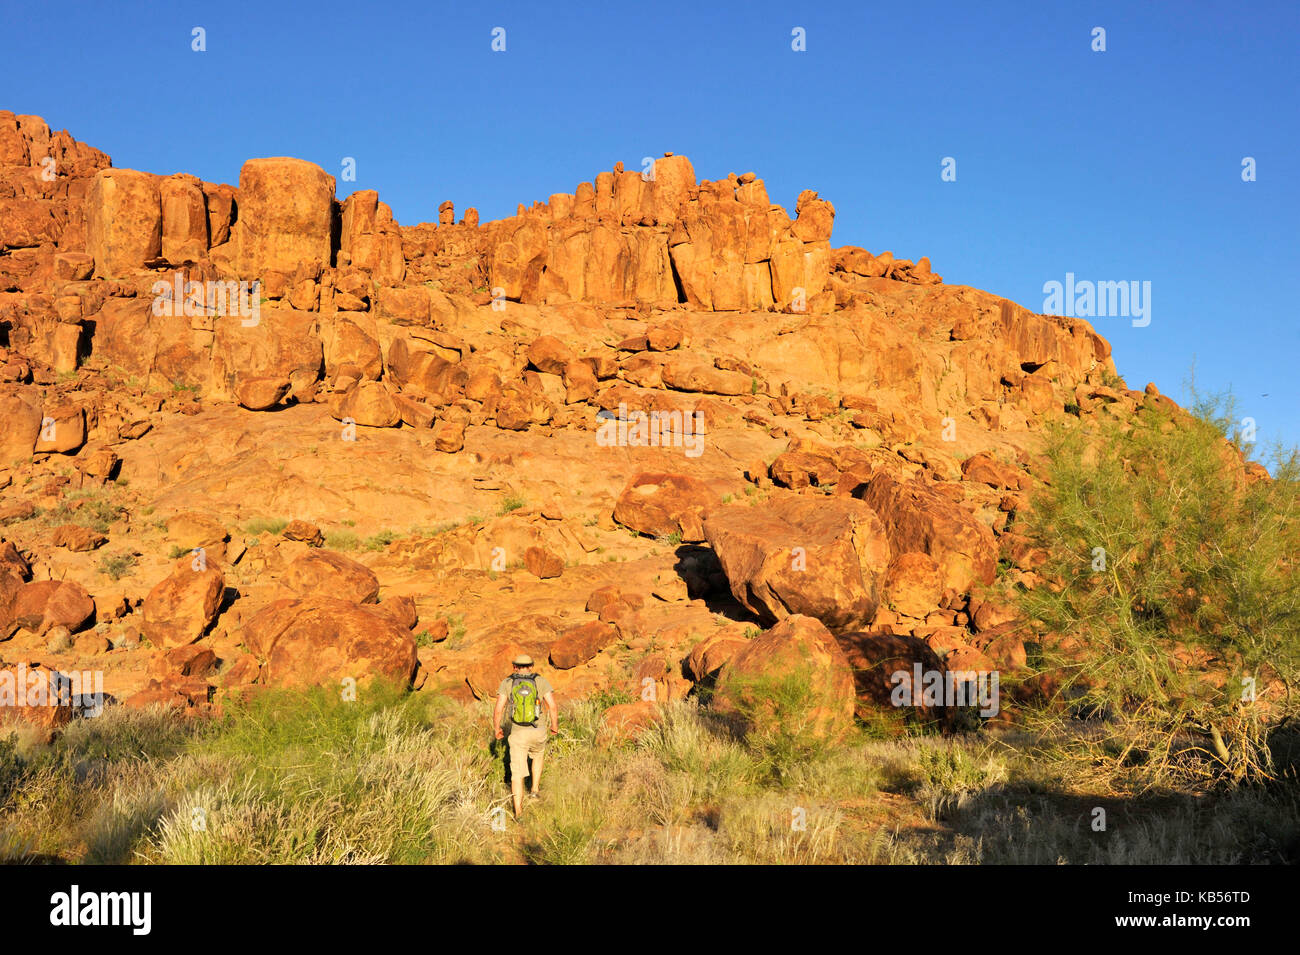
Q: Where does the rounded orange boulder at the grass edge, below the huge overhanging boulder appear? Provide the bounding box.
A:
[714,615,854,739]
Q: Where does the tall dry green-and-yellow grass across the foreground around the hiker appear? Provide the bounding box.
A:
[0,687,1300,864]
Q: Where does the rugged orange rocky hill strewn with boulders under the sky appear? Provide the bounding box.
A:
[0,112,1196,738]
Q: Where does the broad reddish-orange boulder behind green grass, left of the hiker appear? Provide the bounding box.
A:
[242,595,417,689]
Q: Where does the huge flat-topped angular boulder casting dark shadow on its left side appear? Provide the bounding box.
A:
[705,496,889,630]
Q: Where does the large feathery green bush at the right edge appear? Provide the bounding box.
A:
[1019,389,1300,780]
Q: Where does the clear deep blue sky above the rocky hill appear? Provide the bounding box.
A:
[0,0,1300,443]
